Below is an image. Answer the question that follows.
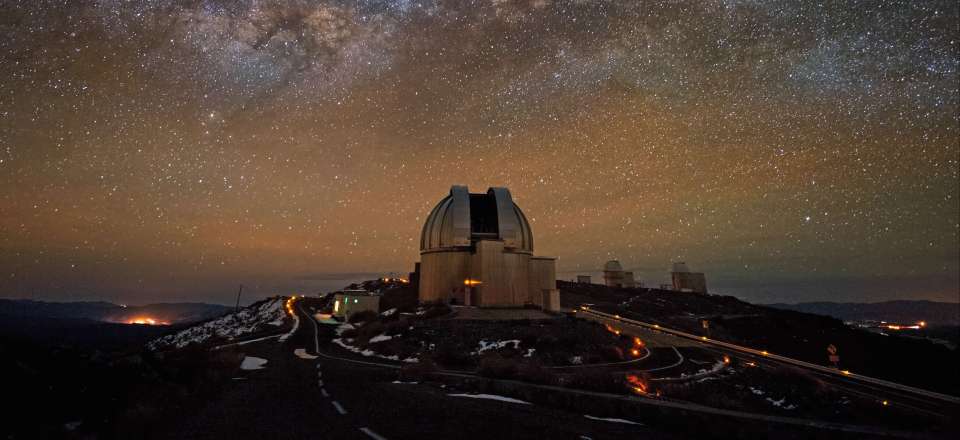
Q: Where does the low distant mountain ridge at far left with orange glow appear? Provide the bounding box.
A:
[0,299,232,324]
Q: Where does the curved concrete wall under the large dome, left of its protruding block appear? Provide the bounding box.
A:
[419,250,473,303]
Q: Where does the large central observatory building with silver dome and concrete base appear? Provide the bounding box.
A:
[418,186,560,310]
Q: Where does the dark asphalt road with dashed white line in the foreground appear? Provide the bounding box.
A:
[161,300,674,440]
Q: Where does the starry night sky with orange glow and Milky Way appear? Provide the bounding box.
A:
[0,0,960,304]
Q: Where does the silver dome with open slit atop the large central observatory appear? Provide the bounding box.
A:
[420,186,533,253]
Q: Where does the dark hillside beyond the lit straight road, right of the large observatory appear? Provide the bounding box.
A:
[557,281,960,395]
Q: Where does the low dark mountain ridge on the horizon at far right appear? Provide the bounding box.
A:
[767,300,960,325]
